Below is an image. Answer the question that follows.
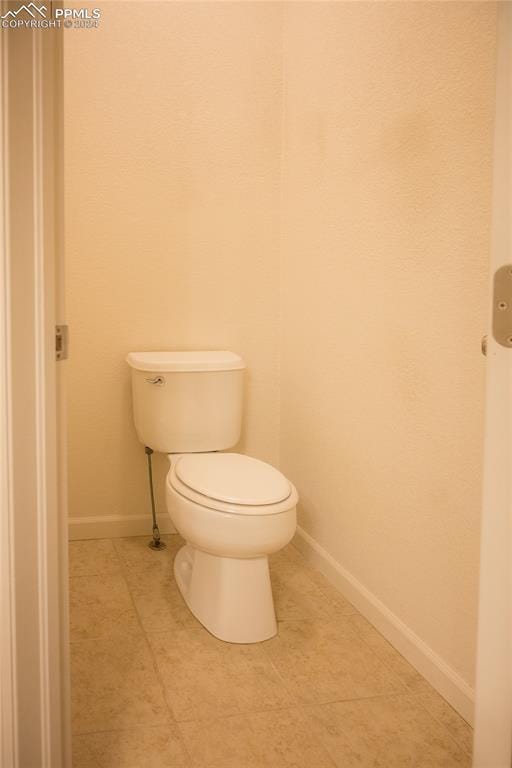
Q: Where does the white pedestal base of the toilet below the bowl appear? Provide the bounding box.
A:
[174,544,277,643]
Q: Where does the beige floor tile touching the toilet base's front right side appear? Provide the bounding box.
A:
[263,617,405,703]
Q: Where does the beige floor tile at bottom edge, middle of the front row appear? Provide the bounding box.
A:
[180,709,334,768]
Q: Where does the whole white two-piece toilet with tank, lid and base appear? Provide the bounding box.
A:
[126,352,298,643]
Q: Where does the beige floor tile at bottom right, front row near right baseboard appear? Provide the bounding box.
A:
[310,695,470,768]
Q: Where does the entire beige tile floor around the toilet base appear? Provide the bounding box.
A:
[70,536,472,768]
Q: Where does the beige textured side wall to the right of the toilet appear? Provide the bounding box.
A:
[281,3,495,681]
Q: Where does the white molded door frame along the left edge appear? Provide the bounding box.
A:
[0,13,71,768]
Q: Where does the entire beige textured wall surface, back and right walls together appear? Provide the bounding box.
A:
[66,2,495,682]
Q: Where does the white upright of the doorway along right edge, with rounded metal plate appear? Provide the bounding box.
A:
[473,0,512,768]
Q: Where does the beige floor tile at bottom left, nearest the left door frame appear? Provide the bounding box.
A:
[82,723,191,768]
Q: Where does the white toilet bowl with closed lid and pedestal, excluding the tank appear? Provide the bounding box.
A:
[166,453,298,643]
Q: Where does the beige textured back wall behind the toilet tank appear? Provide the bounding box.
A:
[65,2,281,517]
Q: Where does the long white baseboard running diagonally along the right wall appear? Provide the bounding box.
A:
[293,527,474,723]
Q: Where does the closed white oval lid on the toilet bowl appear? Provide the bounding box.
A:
[176,453,292,506]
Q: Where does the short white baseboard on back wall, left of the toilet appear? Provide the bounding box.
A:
[69,515,176,541]
